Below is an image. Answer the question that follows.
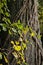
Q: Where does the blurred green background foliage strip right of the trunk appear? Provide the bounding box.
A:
[38,0,43,45]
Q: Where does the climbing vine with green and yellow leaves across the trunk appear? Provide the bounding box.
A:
[0,0,41,65]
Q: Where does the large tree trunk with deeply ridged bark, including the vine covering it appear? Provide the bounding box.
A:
[0,0,42,65]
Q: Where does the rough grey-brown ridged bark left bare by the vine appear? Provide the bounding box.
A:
[6,0,43,65]
